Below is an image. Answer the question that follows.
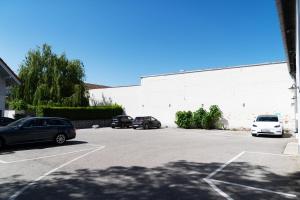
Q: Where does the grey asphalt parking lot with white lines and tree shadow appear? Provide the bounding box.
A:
[0,128,300,200]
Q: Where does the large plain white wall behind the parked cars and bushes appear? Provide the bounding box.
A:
[90,63,295,129]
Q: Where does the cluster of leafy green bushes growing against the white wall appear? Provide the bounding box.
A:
[175,105,222,129]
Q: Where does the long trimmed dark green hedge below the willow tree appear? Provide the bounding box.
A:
[36,105,123,120]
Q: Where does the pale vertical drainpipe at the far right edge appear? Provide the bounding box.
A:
[296,0,300,153]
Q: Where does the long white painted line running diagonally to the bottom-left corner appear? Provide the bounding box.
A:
[8,146,105,200]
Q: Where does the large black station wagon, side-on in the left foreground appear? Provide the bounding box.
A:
[0,117,76,147]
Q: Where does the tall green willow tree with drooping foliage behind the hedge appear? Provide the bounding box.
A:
[10,44,88,106]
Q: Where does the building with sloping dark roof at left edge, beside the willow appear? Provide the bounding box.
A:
[0,58,21,116]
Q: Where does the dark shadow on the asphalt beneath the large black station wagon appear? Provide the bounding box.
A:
[0,140,87,155]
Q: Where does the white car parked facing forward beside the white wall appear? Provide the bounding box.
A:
[251,115,283,136]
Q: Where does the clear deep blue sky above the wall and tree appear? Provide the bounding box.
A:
[0,0,285,86]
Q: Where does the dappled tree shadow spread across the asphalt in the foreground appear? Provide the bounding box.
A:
[0,160,300,200]
